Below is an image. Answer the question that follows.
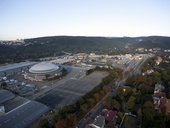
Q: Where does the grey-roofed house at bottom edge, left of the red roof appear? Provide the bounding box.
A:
[85,115,105,128]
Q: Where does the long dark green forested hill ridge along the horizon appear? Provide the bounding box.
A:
[0,36,170,63]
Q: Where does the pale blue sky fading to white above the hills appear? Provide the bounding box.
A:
[0,0,170,40]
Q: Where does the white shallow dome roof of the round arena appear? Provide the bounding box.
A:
[29,62,59,73]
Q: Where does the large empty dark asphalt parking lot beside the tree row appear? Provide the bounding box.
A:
[36,71,108,108]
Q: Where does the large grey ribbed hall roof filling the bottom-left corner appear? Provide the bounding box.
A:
[0,101,49,128]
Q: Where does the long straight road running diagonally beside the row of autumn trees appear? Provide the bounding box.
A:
[77,56,149,128]
